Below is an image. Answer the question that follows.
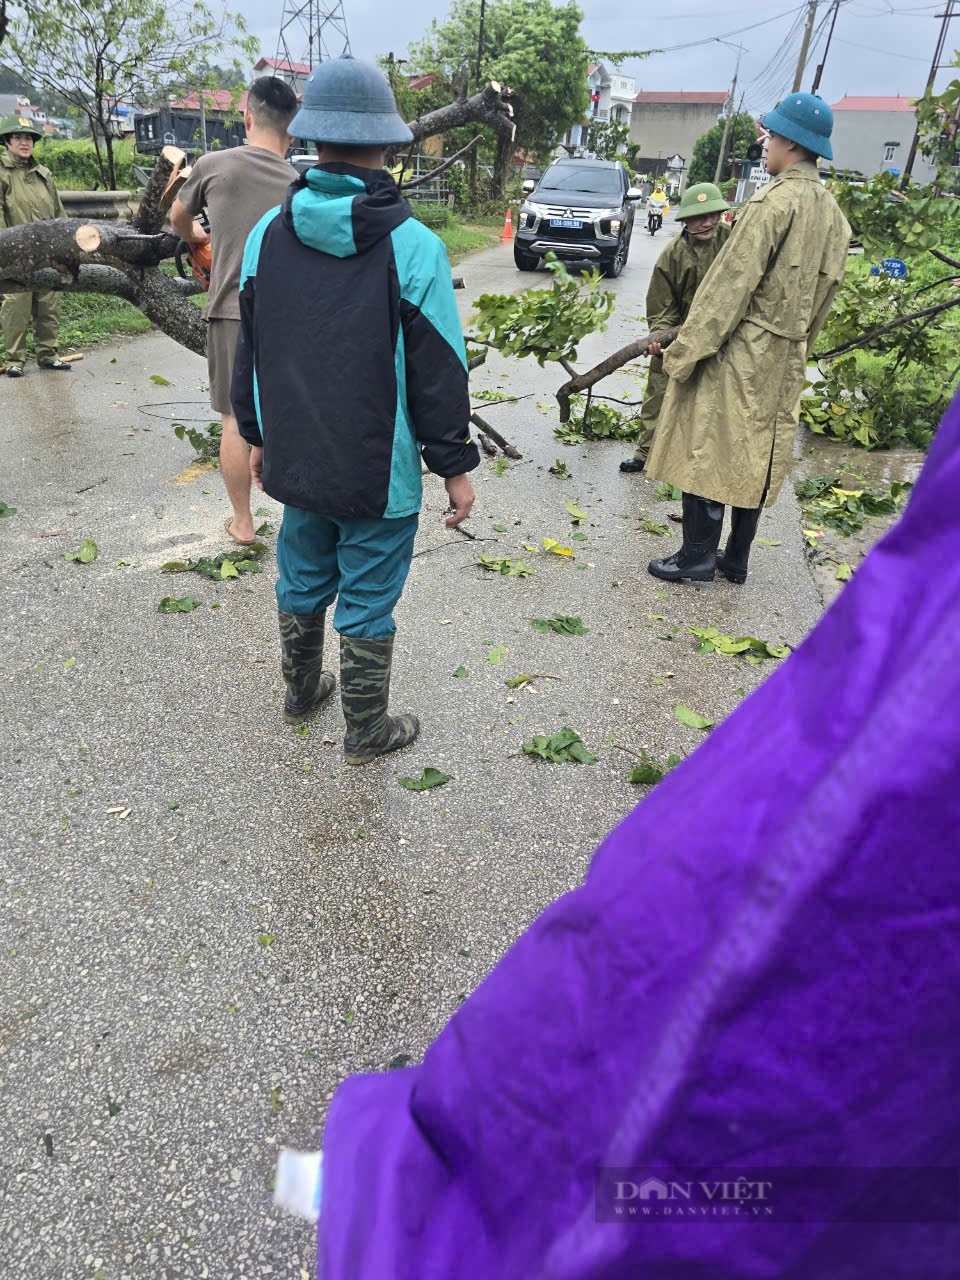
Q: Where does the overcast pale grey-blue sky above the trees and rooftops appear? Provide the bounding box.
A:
[234,0,960,113]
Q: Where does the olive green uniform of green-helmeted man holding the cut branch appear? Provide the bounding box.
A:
[636,220,732,462]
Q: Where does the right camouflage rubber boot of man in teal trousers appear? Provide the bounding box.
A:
[340,636,420,764]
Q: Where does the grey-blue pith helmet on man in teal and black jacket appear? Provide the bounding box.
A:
[289,54,413,147]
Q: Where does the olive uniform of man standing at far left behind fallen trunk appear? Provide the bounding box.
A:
[0,146,65,365]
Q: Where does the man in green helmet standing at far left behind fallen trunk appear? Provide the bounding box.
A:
[0,115,70,378]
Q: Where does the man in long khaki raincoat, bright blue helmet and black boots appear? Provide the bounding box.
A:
[646,93,850,582]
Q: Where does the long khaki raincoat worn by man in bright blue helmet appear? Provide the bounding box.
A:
[646,163,850,507]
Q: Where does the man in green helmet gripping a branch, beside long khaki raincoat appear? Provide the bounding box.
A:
[620,182,731,471]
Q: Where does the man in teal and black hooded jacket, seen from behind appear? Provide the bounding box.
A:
[230,56,480,764]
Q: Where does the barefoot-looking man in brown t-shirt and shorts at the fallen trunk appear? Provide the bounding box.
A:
[170,76,298,543]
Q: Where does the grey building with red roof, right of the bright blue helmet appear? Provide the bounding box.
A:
[831,95,936,186]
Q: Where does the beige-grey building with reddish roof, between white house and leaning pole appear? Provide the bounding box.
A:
[630,90,728,192]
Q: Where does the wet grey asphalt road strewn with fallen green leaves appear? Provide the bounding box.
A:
[0,222,819,1280]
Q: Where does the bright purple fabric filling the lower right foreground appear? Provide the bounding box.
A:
[319,402,960,1280]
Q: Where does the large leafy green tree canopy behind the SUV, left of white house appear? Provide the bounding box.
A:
[404,0,589,159]
